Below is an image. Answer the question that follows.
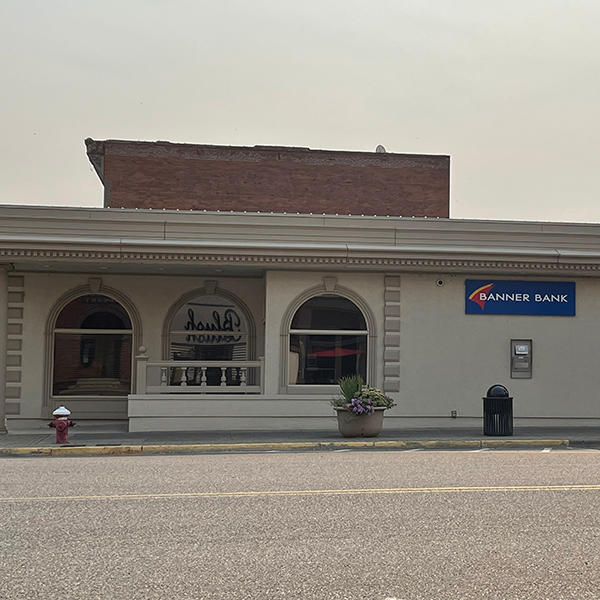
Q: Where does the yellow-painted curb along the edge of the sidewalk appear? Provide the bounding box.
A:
[0,439,570,456]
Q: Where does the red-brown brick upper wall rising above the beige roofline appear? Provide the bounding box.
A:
[86,139,450,217]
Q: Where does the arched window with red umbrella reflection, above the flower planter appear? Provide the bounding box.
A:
[289,295,369,385]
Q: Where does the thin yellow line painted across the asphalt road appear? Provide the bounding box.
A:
[0,484,600,502]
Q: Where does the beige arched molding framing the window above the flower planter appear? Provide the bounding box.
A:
[279,283,377,394]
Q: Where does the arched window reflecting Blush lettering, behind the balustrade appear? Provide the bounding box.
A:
[168,293,250,385]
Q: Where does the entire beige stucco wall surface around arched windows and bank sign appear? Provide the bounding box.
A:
[9,271,600,427]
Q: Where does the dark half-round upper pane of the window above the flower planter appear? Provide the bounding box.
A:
[292,296,367,331]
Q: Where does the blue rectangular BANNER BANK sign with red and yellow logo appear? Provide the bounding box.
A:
[465,279,575,317]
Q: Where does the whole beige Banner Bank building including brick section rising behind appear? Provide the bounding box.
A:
[0,140,600,431]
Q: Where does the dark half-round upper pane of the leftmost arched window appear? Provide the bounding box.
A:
[56,294,131,329]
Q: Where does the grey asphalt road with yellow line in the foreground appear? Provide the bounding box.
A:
[0,450,600,600]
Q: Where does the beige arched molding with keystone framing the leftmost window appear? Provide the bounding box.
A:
[43,278,143,414]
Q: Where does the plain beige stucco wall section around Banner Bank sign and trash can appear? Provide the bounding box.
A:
[398,274,600,419]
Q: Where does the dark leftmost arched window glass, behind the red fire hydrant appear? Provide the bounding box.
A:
[52,294,133,396]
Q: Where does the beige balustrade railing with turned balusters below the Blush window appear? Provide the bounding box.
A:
[136,346,264,394]
